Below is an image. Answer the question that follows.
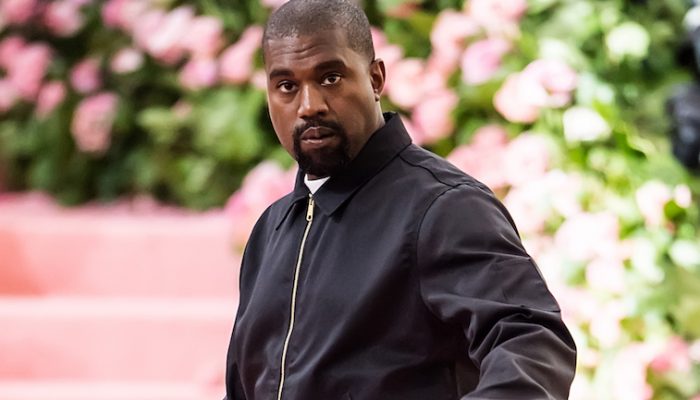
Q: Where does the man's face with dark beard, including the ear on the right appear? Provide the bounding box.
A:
[265,30,384,178]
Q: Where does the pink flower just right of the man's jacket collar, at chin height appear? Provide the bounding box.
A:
[412,89,459,143]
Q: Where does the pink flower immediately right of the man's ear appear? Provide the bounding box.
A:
[384,58,425,109]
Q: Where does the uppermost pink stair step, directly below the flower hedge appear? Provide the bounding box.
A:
[0,194,240,298]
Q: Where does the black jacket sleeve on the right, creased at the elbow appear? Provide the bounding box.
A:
[416,184,576,400]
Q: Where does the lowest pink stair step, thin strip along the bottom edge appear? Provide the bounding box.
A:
[0,380,224,400]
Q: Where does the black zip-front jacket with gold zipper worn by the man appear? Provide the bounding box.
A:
[226,114,576,400]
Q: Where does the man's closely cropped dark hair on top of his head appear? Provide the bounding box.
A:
[262,0,374,61]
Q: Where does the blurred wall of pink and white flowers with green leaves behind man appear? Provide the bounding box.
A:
[0,0,700,399]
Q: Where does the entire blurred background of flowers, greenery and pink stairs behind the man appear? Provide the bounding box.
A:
[0,0,700,400]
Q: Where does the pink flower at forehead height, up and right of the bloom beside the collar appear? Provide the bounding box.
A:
[462,38,511,85]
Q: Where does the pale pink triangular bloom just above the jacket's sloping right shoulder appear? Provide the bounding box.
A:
[447,125,508,189]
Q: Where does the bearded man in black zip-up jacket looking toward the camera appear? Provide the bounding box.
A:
[226,0,576,400]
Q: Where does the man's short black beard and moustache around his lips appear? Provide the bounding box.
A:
[294,119,351,178]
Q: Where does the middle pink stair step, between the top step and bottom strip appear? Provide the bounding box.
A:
[0,297,237,382]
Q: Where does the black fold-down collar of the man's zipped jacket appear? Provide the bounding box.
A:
[277,113,411,227]
